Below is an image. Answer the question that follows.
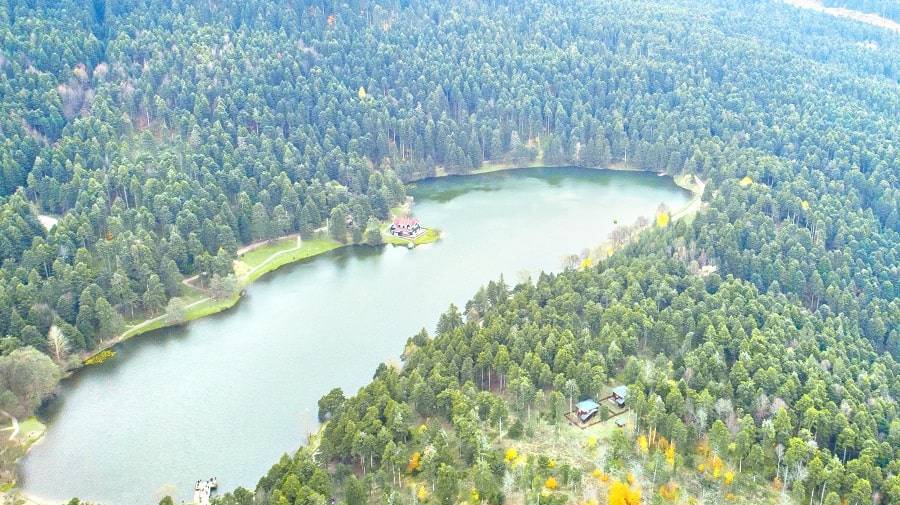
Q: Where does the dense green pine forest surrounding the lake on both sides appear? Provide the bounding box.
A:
[0,0,900,505]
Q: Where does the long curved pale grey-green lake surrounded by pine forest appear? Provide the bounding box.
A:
[21,168,691,505]
